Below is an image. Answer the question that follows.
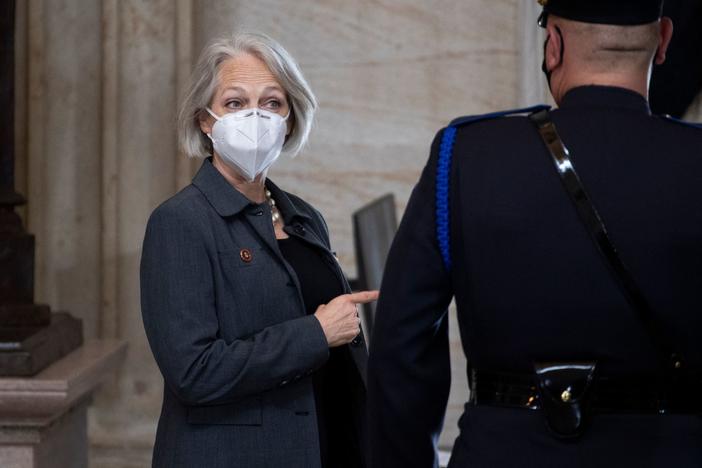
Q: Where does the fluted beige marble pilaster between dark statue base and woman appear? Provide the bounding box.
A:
[17,0,179,466]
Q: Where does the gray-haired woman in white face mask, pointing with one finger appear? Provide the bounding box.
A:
[141,34,377,468]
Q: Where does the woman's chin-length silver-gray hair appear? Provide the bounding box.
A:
[178,32,317,158]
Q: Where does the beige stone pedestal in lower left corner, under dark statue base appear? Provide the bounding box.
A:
[0,340,126,468]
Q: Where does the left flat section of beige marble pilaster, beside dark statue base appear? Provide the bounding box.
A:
[26,0,101,337]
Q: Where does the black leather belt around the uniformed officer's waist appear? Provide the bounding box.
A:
[470,371,702,414]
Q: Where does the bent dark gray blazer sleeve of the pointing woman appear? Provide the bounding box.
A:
[141,205,329,405]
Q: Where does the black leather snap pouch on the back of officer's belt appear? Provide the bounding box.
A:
[534,361,597,439]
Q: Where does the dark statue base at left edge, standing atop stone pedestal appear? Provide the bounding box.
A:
[0,1,83,376]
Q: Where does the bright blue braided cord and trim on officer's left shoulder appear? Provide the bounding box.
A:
[436,105,550,271]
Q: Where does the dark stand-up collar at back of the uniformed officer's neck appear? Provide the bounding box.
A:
[560,85,651,114]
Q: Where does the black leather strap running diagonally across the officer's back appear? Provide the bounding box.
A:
[529,110,683,370]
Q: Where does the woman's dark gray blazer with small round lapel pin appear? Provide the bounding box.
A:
[141,160,367,468]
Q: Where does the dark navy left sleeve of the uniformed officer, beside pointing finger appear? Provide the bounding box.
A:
[368,129,452,468]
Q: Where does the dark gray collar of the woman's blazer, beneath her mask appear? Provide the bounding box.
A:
[193,158,309,224]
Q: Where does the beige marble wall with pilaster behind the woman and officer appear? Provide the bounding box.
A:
[16,0,702,468]
